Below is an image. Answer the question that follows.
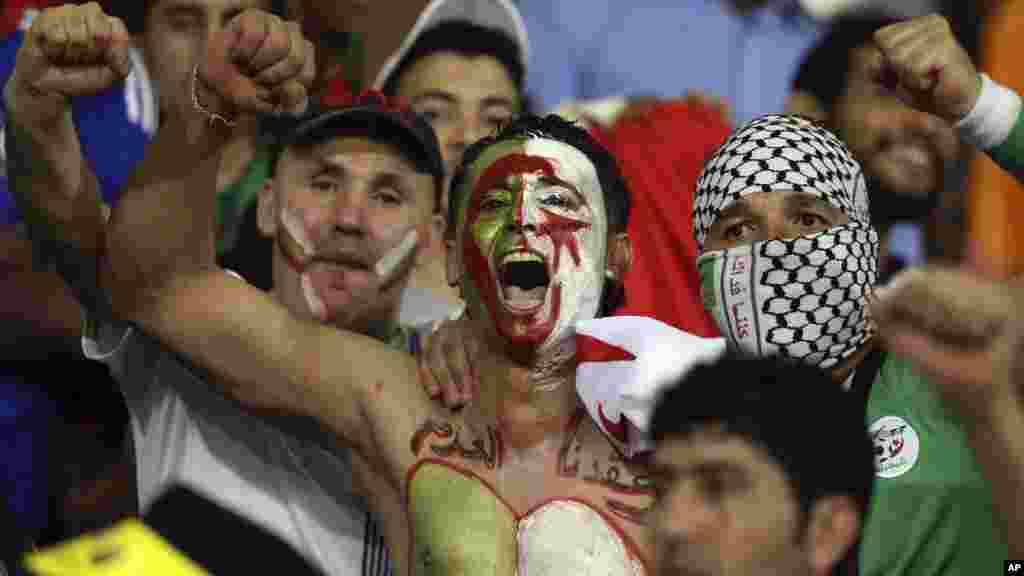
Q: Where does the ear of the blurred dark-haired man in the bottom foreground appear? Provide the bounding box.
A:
[806,496,860,574]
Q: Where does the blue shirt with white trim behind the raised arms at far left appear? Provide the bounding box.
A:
[0,32,152,224]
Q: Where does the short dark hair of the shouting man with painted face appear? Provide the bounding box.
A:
[447,114,630,233]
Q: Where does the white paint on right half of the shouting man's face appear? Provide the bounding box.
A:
[512,138,608,351]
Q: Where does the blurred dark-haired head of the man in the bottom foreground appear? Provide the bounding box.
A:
[650,355,874,576]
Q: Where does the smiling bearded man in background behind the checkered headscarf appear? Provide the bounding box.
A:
[791,15,958,280]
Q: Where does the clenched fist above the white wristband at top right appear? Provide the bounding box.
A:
[874,14,981,123]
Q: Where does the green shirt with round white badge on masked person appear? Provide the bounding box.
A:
[859,355,1009,576]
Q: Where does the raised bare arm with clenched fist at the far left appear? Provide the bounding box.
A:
[3,4,130,317]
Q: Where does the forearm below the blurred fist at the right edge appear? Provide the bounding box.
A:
[967,402,1024,558]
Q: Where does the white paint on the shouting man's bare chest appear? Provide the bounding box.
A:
[516,500,644,576]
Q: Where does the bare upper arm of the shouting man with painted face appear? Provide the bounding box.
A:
[137,271,391,449]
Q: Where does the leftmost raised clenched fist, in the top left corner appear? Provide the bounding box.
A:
[8,2,131,106]
